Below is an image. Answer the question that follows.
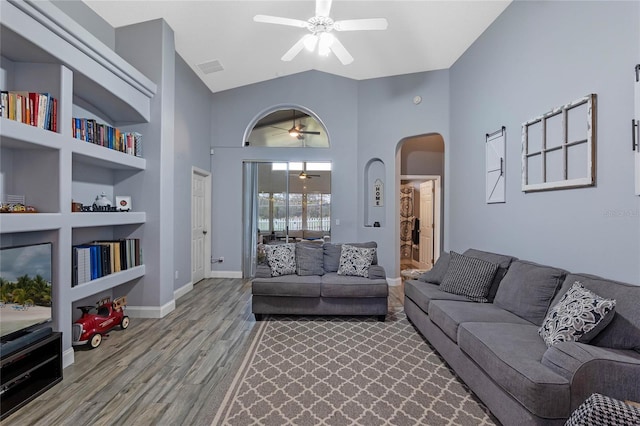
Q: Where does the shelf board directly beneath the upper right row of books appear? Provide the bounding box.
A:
[70,139,147,170]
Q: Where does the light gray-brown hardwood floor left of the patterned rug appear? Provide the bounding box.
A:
[2,279,404,426]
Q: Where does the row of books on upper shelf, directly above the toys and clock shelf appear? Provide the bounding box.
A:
[72,118,142,157]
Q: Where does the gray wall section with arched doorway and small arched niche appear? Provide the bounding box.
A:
[356,70,449,278]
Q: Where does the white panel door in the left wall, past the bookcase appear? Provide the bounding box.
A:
[191,173,207,284]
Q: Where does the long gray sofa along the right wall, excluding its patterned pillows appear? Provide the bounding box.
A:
[405,249,640,425]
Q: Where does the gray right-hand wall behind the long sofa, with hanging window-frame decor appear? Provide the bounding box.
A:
[445,1,640,284]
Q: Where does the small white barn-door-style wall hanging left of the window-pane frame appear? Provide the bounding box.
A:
[485,126,507,204]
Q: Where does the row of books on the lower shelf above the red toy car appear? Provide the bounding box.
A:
[71,238,142,287]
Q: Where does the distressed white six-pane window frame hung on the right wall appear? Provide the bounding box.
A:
[522,94,596,192]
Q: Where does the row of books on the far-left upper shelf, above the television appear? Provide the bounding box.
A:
[0,91,58,132]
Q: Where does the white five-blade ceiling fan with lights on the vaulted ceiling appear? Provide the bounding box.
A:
[253,0,388,65]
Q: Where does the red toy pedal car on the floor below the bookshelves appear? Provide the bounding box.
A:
[72,297,129,348]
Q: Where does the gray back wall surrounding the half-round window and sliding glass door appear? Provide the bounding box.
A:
[211,71,358,272]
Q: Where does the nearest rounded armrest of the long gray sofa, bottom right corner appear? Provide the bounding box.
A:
[542,342,640,410]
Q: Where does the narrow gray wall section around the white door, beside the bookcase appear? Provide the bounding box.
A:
[173,54,211,289]
